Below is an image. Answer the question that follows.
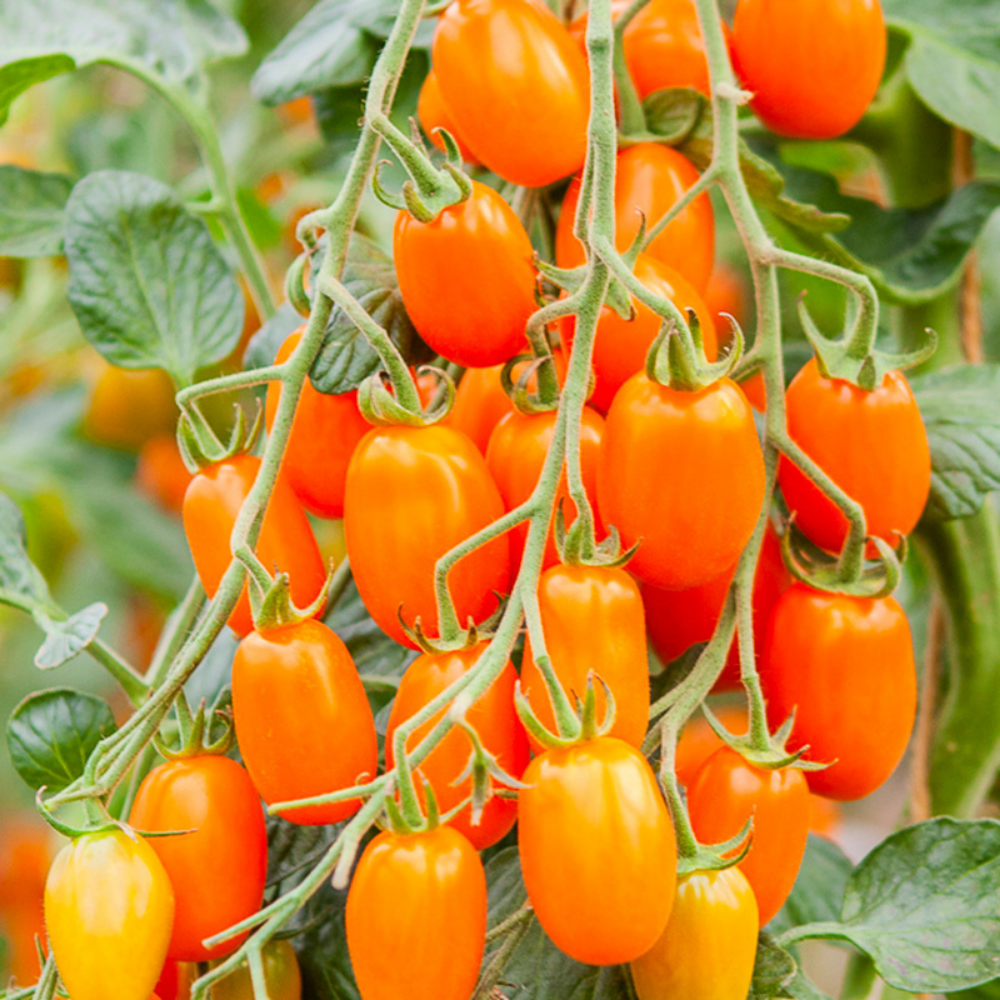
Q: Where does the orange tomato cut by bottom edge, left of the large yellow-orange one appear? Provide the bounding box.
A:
[346,826,486,1000]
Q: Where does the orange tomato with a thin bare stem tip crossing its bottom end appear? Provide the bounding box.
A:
[233,620,378,826]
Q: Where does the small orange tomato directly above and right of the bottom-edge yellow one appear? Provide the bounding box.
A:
[688,746,810,927]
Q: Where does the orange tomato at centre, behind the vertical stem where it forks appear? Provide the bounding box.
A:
[486,406,604,568]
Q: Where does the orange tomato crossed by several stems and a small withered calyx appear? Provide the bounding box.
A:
[385,644,528,851]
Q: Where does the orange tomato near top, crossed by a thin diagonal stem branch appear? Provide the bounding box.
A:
[556,142,715,292]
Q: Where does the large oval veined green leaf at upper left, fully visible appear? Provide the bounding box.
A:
[66,170,243,384]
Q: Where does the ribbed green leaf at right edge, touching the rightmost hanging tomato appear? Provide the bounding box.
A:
[911,364,1000,520]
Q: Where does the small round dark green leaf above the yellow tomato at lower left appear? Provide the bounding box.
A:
[7,688,115,792]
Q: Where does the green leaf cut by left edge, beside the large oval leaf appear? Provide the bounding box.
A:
[0,166,73,257]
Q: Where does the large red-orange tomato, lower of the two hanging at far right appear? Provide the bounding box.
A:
[761,583,917,799]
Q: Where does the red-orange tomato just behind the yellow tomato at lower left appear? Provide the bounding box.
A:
[129,755,267,962]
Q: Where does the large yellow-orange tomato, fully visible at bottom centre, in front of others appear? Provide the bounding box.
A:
[518,736,677,965]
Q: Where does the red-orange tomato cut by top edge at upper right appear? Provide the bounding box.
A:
[733,0,886,139]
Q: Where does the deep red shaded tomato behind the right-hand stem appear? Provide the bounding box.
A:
[642,527,792,691]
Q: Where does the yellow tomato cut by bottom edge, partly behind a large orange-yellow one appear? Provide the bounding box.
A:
[632,868,759,1000]
